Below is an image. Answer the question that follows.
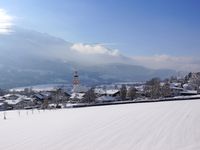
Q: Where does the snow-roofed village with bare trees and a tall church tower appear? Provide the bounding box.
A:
[0,71,200,111]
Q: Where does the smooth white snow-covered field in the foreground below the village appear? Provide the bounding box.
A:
[0,100,200,150]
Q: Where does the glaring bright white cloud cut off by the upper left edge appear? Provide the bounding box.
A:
[0,9,13,34]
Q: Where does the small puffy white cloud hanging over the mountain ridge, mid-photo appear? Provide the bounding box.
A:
[71,43,119,56]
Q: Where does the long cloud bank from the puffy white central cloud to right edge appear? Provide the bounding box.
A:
[71,43,200,71]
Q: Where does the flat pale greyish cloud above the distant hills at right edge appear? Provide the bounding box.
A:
[132,55,200,71]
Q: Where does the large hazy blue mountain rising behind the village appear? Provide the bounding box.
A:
[0,27,175,88]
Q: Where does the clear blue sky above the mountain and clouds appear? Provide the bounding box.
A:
[0,0,200,57]
